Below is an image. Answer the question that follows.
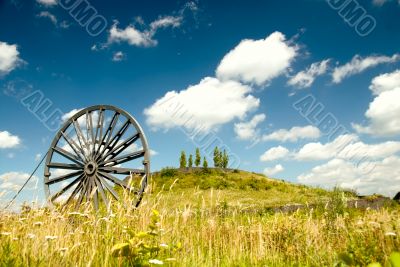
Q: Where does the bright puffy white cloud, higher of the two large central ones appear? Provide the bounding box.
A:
[216,32,298,85]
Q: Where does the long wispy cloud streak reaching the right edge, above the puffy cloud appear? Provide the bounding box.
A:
[332,54,400,83]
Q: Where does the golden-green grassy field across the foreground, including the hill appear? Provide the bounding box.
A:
[0,169,400,266]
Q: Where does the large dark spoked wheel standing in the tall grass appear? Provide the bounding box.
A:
[44,105,150,210]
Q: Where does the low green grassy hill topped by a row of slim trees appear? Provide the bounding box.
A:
[150,168,342,213]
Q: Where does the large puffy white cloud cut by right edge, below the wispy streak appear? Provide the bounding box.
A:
[353,70,400,136]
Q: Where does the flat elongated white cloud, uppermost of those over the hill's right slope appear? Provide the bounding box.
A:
[262,125,321,142]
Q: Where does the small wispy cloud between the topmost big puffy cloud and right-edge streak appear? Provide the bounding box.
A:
[288,59,330,88]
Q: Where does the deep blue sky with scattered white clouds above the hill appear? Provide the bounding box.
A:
[0,0,400,207]
